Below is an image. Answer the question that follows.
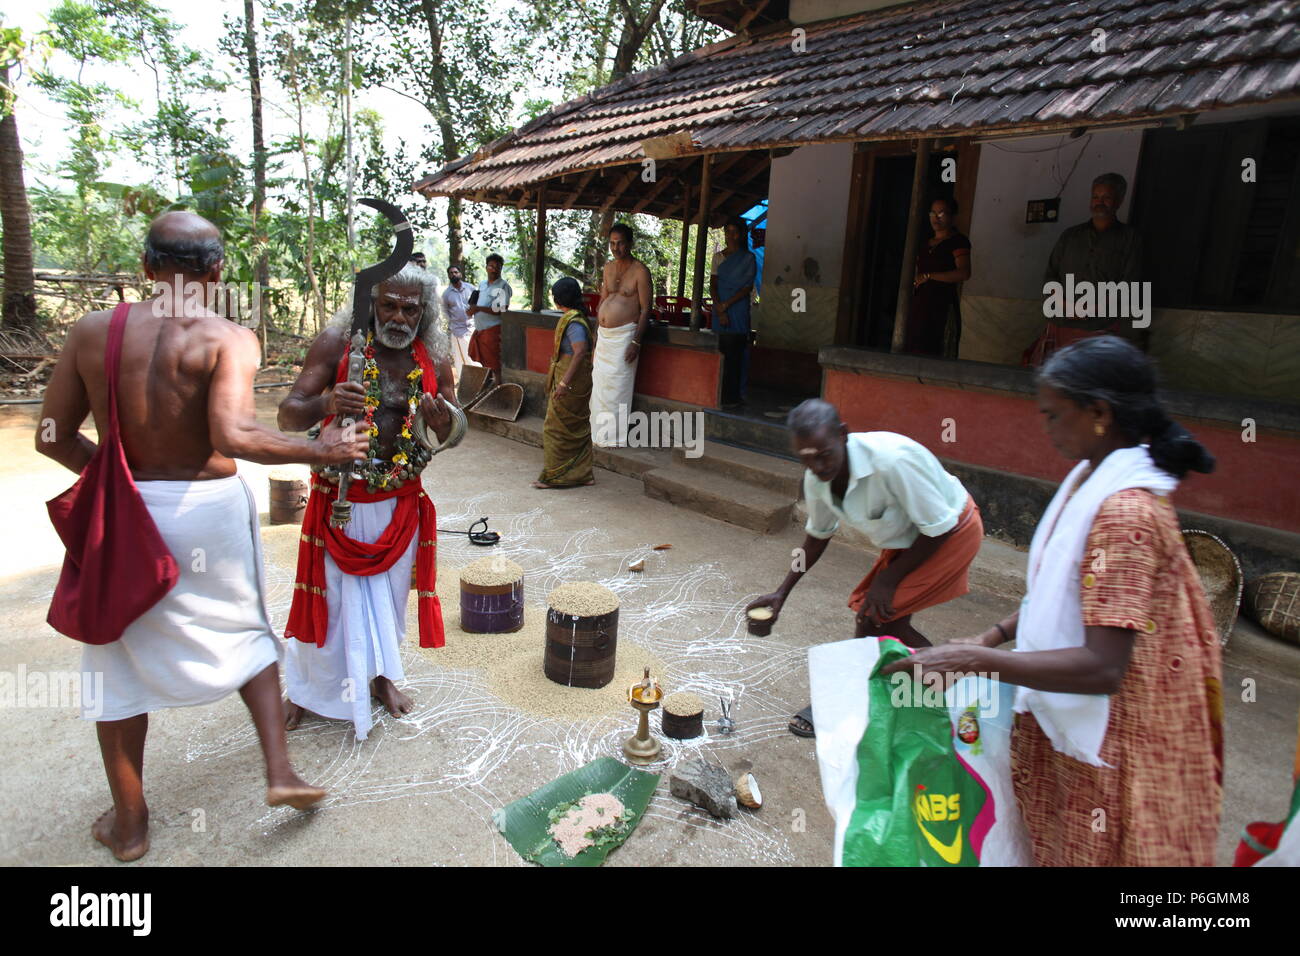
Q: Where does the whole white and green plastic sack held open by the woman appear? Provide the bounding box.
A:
[809,637,1032,866]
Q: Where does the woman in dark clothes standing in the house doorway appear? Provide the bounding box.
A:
[902,199,971,359]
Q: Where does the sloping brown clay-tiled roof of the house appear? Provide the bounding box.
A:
[416,0,1300,215]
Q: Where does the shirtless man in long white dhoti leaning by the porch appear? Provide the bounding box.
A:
[592,222,653,447]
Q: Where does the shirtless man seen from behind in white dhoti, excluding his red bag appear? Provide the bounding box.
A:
[36,212,367,861]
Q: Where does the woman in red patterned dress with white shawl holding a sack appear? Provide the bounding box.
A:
[892,336,1223,866]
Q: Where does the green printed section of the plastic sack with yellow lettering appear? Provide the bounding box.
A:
[844,639,993,866]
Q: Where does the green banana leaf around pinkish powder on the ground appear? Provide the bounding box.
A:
[493,757,659,866]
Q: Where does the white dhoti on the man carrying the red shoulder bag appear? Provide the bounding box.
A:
[82,475,278,721]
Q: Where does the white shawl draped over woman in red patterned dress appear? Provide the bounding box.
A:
[1015,445,1178,766]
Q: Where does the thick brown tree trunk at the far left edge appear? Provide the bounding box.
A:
[0,66,36,329]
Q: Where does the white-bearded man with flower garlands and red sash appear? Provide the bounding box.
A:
[278,264,465,740]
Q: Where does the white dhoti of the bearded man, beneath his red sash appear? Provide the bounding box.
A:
[285,498,420,740]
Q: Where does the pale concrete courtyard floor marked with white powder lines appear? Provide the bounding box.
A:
[0,390,1300,866]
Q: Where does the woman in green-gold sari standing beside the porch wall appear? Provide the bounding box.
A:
[533,276,595,488]
